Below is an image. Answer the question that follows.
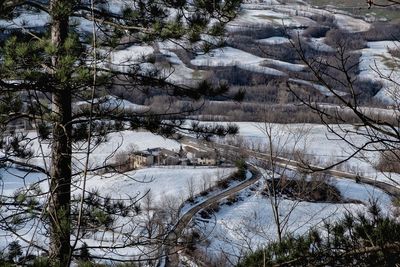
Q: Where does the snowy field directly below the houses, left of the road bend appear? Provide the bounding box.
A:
[83,166,236,206]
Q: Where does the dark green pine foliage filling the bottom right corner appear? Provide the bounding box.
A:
[237,203,400,267]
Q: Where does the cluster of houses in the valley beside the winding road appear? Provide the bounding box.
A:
[128,146,221,169]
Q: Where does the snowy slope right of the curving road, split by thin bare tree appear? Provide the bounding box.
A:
[204,195,363,262]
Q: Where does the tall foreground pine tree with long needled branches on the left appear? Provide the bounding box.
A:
[0,0,242,266]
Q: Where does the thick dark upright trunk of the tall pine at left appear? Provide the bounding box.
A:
[49,0,72,266]
